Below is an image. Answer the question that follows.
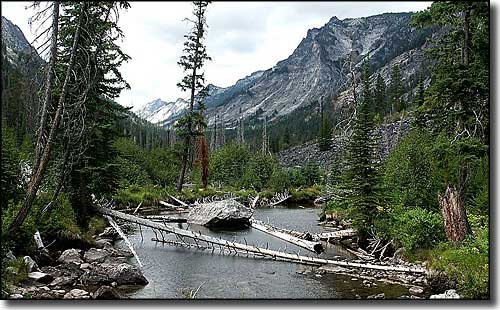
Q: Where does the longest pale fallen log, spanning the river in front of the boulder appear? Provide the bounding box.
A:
[95,206,426,273]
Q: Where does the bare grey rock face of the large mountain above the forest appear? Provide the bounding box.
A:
[139,13,429,126]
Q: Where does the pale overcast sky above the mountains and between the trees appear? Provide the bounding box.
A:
[2,1,430,107]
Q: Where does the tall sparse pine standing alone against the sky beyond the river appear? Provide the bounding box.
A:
[175,1,211,192]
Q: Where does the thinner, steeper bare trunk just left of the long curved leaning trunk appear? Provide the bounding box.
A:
[33,1,60,173]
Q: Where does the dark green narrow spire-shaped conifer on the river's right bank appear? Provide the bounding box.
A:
[342,60,381,244]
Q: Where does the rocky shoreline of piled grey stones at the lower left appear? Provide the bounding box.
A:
[5,227,148,299]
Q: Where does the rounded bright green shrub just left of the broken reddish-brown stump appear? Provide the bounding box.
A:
[392,208,444,252]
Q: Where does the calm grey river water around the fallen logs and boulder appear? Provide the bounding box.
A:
[120,206,408,299]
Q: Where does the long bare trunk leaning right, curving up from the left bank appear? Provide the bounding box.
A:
[6,2,85,240]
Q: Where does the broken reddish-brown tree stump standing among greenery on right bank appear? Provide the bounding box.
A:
[438,185,471,242]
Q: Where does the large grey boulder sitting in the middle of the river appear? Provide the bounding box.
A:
[188,199,253,229]
